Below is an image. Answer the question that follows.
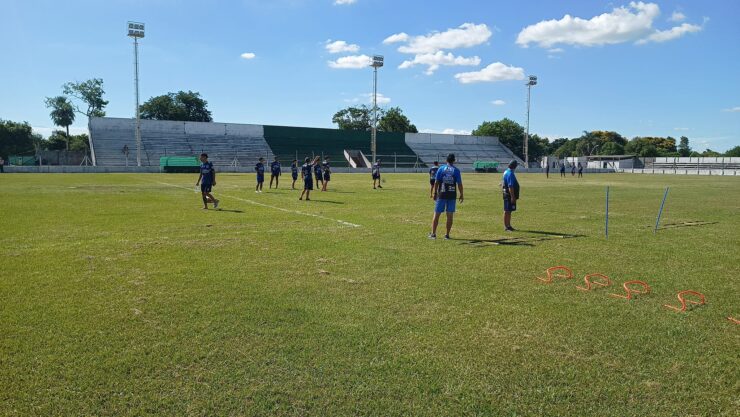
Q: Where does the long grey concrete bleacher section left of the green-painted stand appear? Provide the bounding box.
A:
[90,117,273,166]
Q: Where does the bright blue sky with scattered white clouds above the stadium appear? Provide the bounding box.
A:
[0,0,740,151]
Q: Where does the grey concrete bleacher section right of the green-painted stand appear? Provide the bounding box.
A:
[405,133,523,169]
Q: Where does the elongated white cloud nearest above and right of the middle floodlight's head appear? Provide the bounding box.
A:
[396,23,492,54]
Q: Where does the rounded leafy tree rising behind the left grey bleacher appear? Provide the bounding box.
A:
[139,91,213,122]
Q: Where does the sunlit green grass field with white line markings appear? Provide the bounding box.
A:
[0,174,740,416]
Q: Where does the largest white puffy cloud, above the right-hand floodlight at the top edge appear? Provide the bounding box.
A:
[516,2,660,48]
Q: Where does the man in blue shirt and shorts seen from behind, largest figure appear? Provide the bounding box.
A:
[429,153,463,240]
